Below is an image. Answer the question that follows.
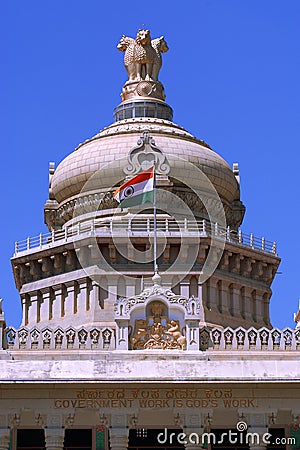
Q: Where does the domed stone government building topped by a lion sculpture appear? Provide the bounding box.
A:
[0,30,300,450]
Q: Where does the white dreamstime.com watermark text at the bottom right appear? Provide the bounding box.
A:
[157,421,296,445]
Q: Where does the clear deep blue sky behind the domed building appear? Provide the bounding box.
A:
[0,0,300,328]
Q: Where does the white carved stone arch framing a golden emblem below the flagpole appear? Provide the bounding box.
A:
[115,284,201,350]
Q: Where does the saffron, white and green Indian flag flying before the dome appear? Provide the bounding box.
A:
[114,166,154,208]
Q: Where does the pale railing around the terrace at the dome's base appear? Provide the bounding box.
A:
[14,217,277,256]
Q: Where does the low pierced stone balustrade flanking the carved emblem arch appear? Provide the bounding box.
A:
[4,326,300,352]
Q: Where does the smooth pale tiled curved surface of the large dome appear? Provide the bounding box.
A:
[51,119,239,203]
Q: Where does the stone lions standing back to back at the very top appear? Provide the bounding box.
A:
[117,30,169,82]
